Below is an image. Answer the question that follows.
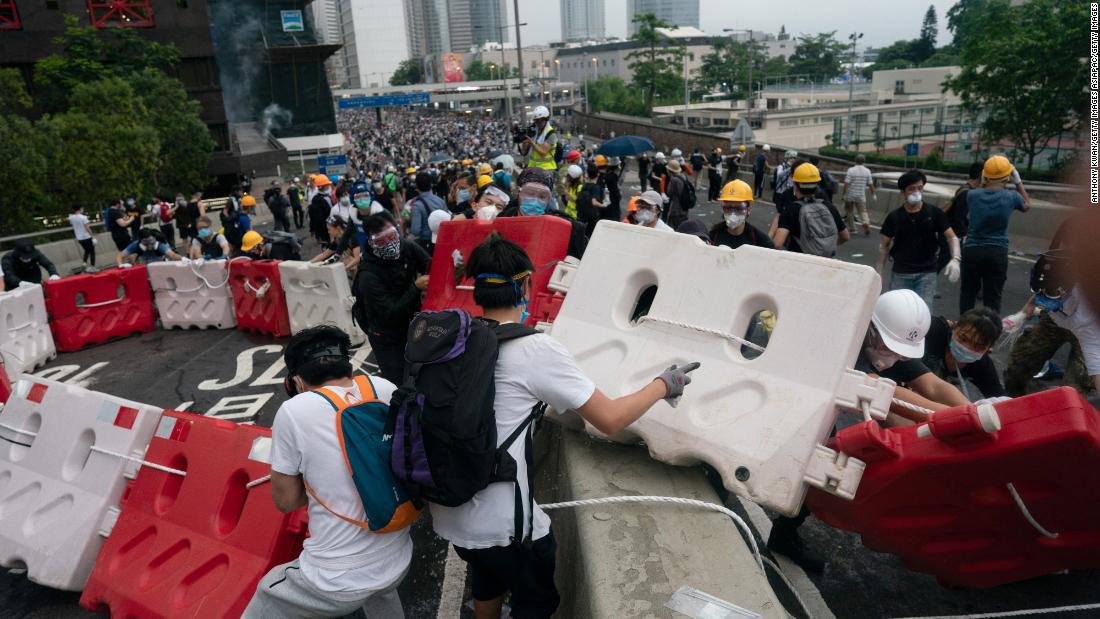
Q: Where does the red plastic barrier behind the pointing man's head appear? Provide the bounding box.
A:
[422,217,572,325]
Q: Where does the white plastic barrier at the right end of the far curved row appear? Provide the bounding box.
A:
[278,261,366,345]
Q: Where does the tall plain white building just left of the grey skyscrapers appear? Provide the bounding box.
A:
[341,0,409,88]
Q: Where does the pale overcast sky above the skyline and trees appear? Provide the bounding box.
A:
[506,0,956,47]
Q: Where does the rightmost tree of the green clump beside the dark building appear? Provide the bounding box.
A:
[130,69,215,195]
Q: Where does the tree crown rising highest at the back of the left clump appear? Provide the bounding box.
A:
[34,15,179,112]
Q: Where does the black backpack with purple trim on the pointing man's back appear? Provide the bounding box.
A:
[386,309,546,541]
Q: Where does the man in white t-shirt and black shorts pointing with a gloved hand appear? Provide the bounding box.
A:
[430,234,699,618]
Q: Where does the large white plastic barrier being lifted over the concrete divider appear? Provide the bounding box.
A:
[550,222,892,515]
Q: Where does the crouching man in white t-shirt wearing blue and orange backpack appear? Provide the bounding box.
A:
[244,325,413,619]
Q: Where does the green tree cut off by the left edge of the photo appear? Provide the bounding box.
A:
[0,69,53,234]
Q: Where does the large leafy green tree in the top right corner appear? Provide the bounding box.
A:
[945,0,1089,168]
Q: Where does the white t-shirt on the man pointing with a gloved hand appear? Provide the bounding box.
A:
[429,333,596,549]
